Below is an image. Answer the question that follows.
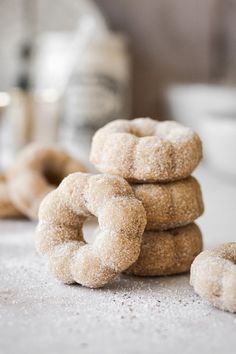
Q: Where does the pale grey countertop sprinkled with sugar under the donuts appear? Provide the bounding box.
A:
[0,167,236,354]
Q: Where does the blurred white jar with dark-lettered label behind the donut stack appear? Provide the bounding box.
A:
[61,17,131,157]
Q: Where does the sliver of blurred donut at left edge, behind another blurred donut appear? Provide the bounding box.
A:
[0,175,22,218]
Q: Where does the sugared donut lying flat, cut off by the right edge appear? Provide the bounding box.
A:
[190,242,236,312]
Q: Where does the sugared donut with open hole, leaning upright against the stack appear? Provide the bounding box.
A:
[35,173,146,288]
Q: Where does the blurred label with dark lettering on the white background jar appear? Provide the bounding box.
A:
[65,73,128,129]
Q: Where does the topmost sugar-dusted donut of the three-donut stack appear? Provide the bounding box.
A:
[90,118,202,182]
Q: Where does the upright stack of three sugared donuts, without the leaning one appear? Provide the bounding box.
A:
[90,118,204,276]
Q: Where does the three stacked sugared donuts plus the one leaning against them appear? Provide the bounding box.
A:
[35,118,203,288]
